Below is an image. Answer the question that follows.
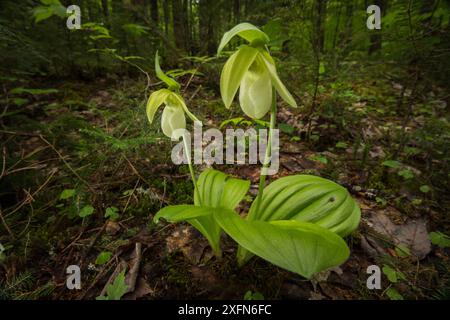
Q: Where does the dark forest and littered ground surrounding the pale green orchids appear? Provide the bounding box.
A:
[0,0,450,300]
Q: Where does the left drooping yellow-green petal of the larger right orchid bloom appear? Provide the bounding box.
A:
[220,46,258,108]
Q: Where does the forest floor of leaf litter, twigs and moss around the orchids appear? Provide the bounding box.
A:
[0,70,450,299]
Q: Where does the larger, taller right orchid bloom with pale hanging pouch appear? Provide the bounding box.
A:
[218,23,297,119]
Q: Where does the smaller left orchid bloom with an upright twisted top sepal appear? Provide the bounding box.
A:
[147,52,199,138]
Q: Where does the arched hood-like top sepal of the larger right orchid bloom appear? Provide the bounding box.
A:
[217,22,270,55]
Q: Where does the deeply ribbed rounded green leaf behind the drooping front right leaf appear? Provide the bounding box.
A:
[237,175,361,264]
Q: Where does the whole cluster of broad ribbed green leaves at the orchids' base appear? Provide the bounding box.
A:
[154,169,360,278]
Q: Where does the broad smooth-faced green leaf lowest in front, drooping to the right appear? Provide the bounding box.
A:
[214,208,350,278]
